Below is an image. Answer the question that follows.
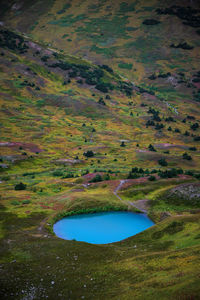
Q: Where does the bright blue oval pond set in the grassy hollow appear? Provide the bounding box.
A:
[53,211,154,244]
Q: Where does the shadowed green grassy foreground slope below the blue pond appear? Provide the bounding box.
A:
[2,204,199,299]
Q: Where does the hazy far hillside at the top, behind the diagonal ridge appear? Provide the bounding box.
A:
[2,0,200,85]
